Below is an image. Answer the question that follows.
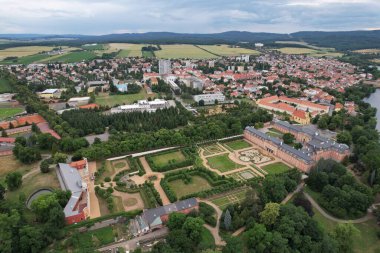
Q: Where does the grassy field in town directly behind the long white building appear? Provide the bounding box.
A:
[95,89,155,107]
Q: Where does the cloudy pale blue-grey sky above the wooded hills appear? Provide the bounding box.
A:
[0,0,380,35]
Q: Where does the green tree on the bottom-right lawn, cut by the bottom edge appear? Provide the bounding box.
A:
[332,223,360,253]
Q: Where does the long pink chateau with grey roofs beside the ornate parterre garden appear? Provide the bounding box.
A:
[244,121,350,173]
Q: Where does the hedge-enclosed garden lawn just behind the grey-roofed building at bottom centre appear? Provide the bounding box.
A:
[168,176,212,198]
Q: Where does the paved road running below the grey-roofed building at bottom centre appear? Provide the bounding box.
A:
[98,227,169,252]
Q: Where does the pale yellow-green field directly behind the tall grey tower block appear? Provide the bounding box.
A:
[155,44,217,59]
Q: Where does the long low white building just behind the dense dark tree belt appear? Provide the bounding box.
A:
[111,99,172,113]
